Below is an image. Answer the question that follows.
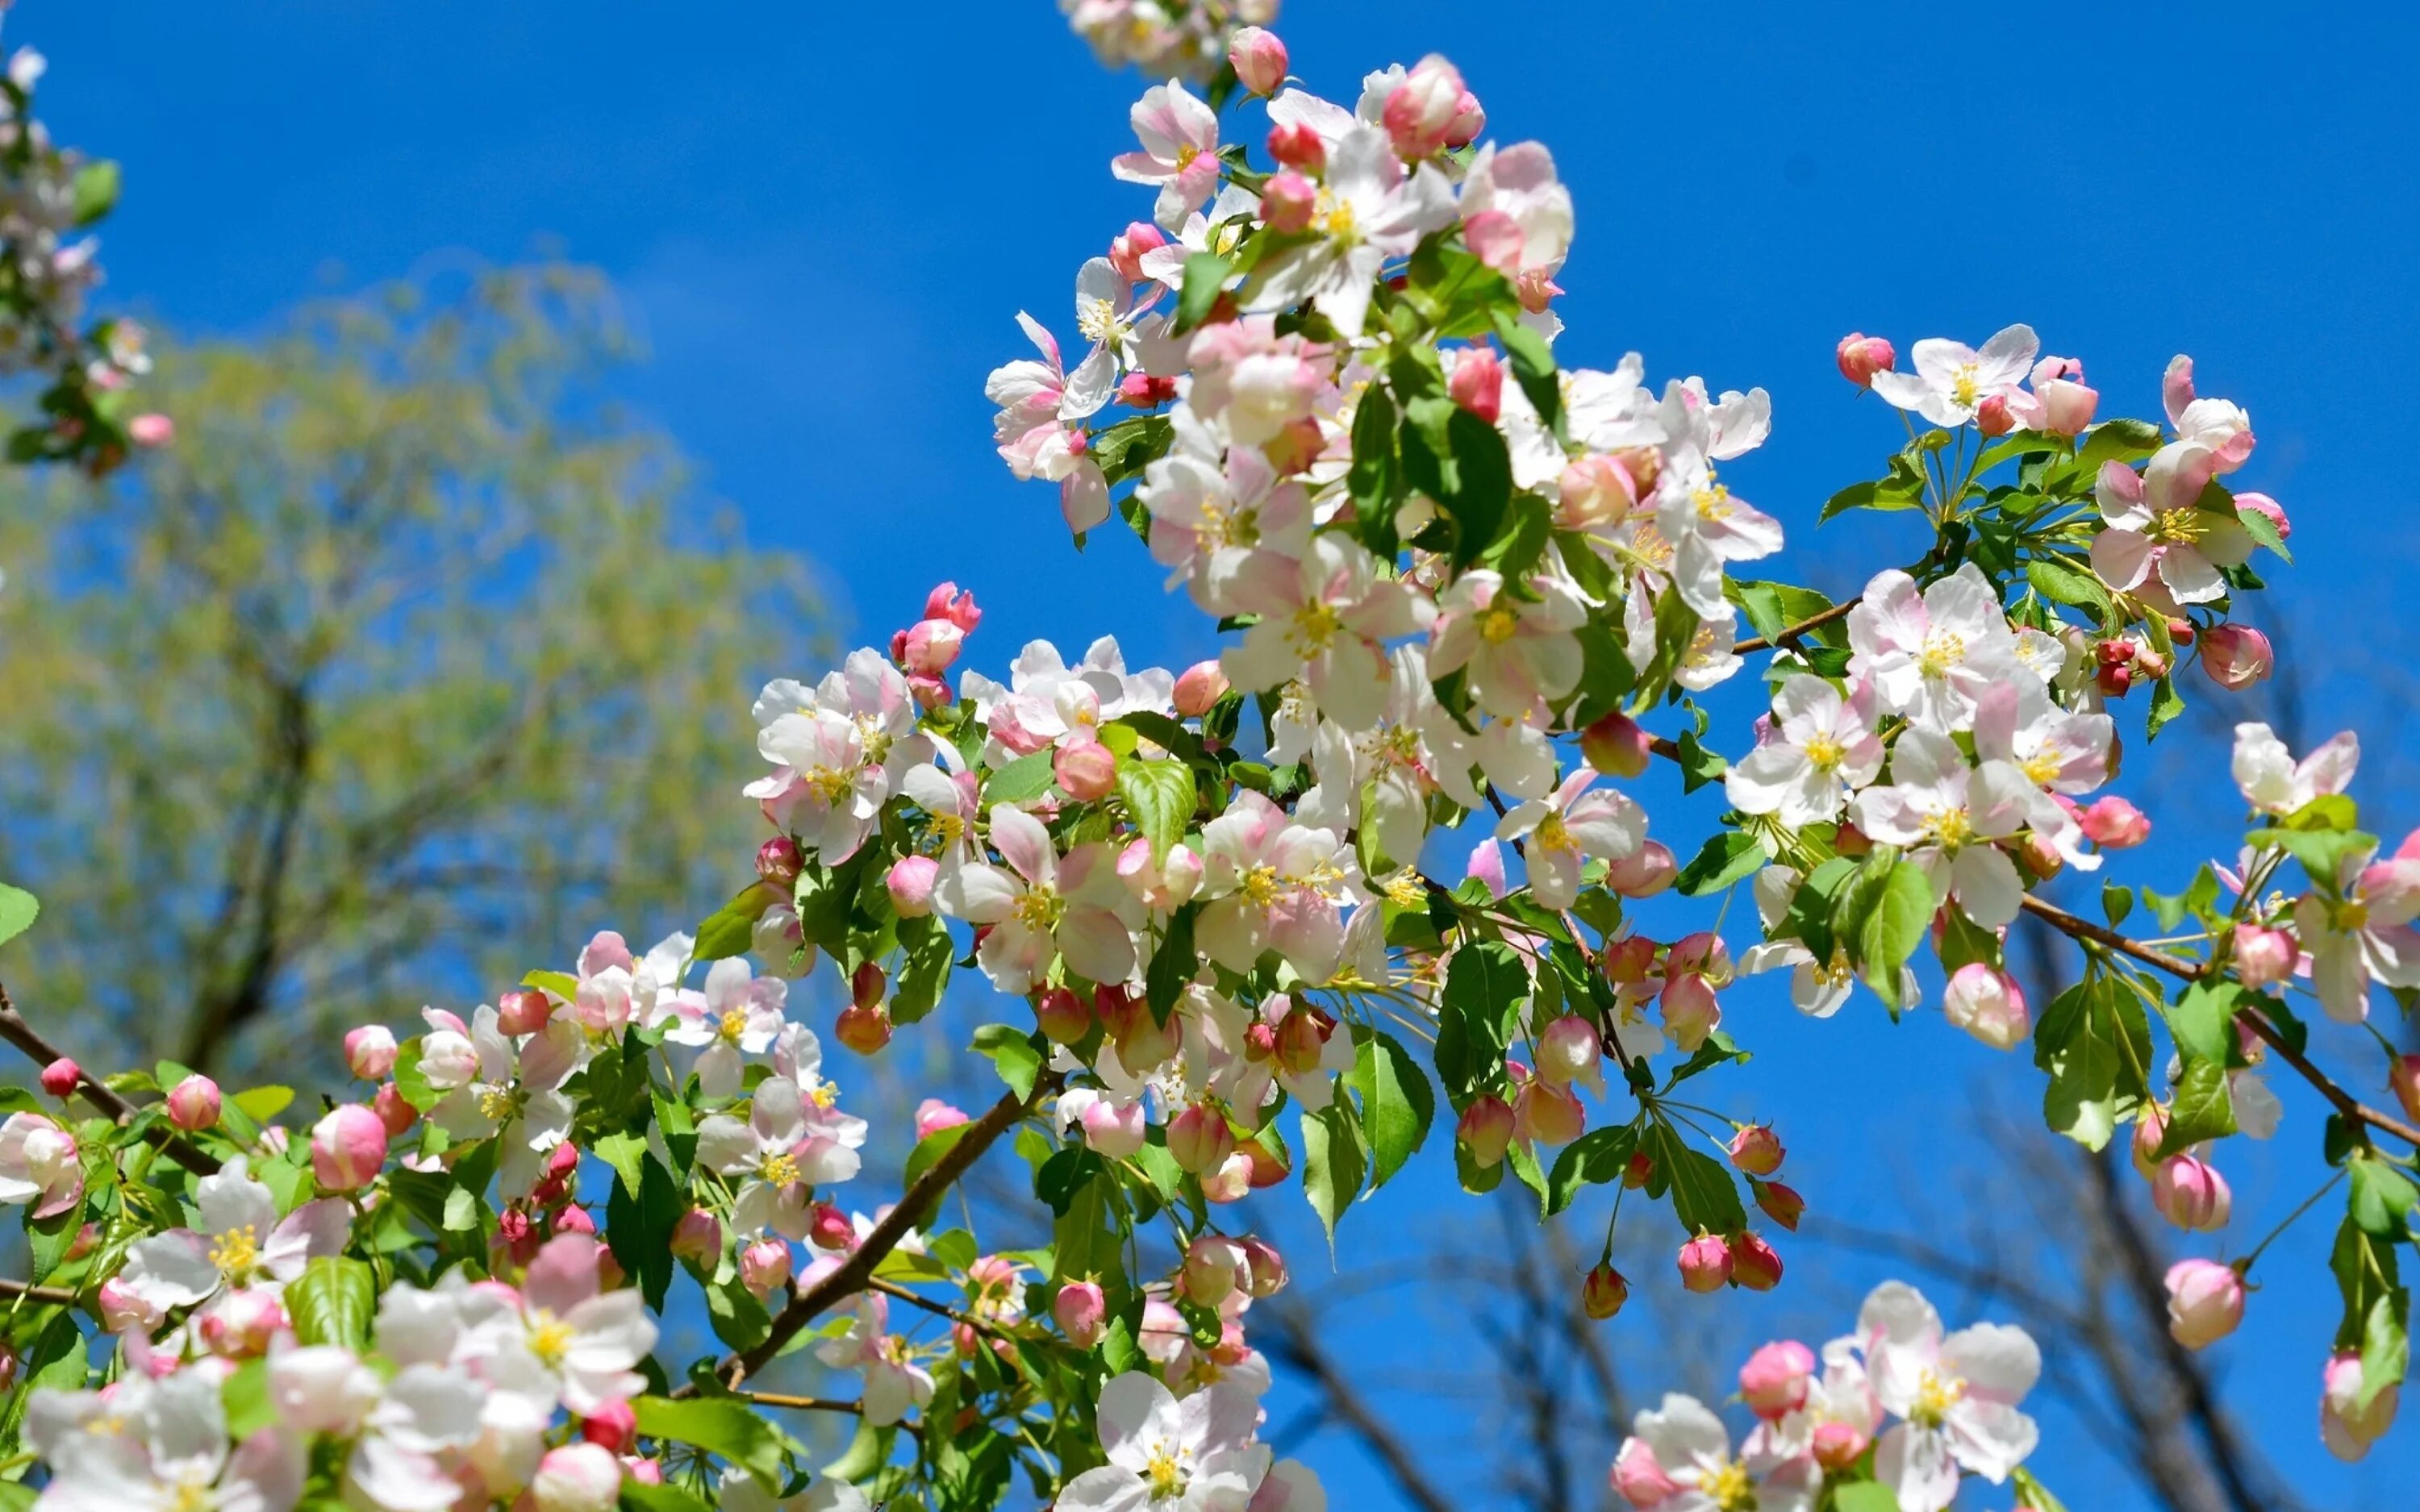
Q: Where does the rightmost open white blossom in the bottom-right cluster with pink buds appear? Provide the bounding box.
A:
[1856,1282,2042,1512]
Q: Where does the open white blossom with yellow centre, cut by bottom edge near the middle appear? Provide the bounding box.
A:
[1058,1369,1268,1512]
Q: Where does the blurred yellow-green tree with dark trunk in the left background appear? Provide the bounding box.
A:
[0,266,823,1079]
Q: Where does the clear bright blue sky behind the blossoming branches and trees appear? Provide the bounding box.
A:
[23,0,2420,1507]
